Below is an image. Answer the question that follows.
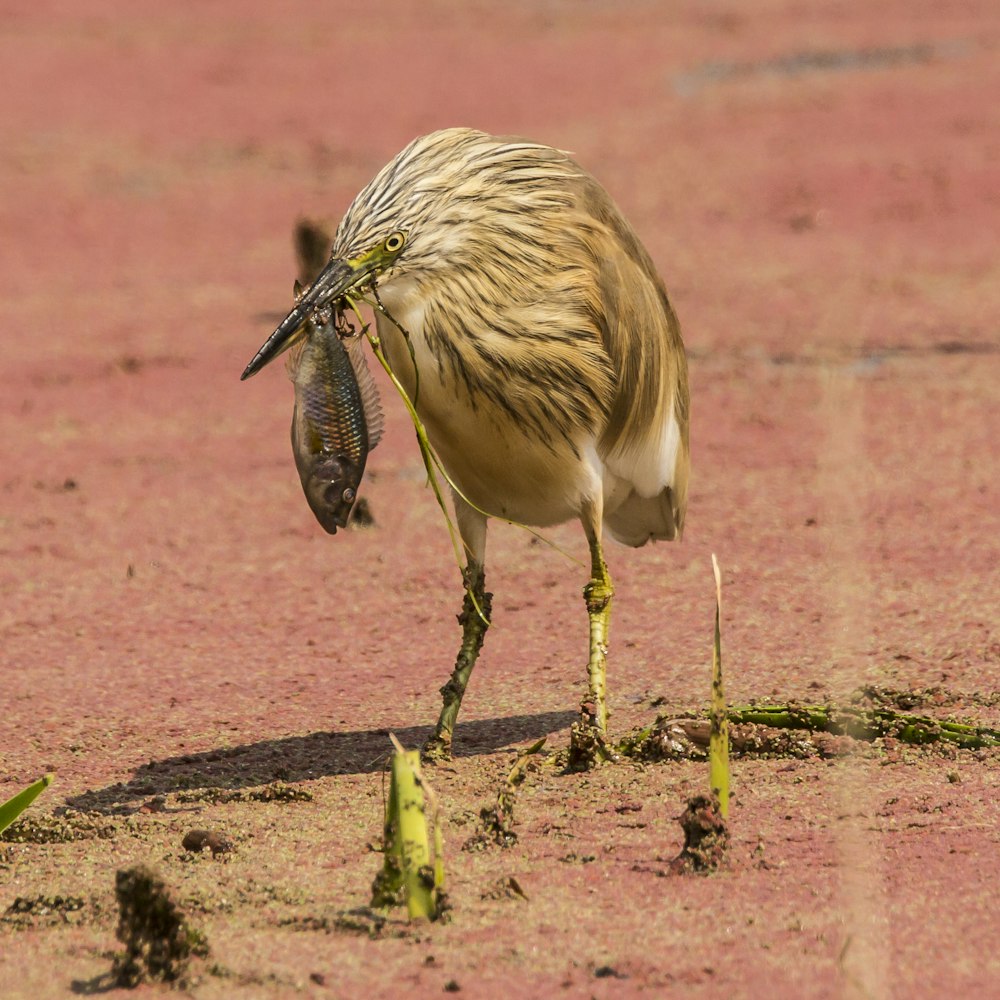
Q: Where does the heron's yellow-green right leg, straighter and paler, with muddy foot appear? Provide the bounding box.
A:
[570,503,615,767]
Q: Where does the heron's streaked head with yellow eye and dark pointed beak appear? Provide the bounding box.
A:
[242,128,579,378]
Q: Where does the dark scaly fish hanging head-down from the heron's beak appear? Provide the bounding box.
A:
[288,310,383,535]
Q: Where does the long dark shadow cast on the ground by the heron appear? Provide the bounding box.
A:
[59,712,577,815]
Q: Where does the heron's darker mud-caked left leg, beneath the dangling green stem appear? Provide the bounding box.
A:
[423,497,493,761]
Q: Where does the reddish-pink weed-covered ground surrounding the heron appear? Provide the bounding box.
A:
[0,0,1000,1000]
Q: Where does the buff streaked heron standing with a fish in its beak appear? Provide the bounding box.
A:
[242,128,690,766]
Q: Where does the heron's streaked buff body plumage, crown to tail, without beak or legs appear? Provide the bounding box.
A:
[340,129,688,545]
